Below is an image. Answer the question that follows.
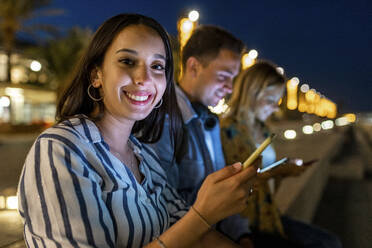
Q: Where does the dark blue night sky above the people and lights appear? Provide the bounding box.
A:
[30,0,372,113]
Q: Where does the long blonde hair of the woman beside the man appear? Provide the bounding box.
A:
[225,61,286,124]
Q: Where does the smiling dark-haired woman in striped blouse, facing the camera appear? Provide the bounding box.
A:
[18,14,255,247]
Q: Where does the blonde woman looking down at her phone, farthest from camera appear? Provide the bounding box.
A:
[221,61,340,247]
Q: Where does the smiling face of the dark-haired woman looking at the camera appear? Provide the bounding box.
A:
[92,25,167,123]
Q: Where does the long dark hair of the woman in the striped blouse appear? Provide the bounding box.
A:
[56,14,182,145]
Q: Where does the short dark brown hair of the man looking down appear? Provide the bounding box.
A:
[182,25,245,68]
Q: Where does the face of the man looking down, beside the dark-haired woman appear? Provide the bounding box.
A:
[194,49,240,106]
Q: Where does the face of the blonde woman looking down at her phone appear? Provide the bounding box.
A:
[254,85,284,122]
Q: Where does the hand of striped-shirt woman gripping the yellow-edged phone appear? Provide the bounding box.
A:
[194,158,261,225]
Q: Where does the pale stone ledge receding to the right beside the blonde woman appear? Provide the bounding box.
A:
[274,131,344,222]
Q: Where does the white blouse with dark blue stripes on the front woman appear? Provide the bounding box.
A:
[18,116,188,248]
